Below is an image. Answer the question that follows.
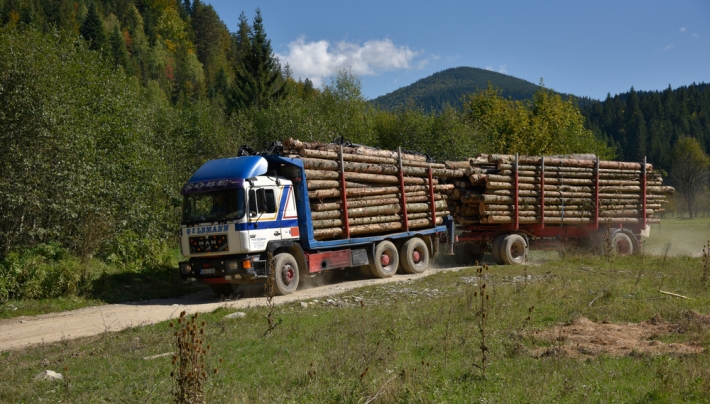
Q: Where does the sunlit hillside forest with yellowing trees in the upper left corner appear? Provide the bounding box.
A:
[0,0,278,104]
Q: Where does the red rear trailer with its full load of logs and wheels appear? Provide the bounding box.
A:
[454,155,673,265]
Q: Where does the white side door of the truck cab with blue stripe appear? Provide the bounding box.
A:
[248,186,281,252]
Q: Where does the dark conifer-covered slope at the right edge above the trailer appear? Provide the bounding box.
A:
[581,84,710,170]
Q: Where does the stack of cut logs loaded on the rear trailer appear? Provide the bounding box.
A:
[446,154,674,225]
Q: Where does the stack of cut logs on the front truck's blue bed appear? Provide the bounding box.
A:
[282,139,464,240]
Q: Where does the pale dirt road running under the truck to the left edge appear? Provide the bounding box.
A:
[0,267,462,351]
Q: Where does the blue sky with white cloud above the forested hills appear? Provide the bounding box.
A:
[205,0,710,100]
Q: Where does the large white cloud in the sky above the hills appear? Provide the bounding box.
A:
[276,37,422,87]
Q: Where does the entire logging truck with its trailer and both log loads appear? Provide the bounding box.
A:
[180,139,674,295]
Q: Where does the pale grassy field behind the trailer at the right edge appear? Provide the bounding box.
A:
[644,217,710,256]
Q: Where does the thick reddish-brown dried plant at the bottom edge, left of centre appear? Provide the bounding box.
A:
[170,311,222,404]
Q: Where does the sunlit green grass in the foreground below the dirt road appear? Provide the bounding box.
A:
[0,255,710,403]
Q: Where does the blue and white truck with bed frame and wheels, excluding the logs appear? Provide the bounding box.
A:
[180,154,453,295]
